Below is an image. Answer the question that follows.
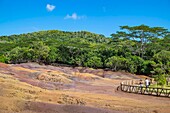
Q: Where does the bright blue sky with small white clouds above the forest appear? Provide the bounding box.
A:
[0,0,170,36]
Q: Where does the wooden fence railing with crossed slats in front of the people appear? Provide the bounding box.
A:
[120,83,170,97]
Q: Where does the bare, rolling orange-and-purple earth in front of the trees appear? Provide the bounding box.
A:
[0,63,170,113]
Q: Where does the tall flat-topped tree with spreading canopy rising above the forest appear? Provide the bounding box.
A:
[112,25,169,58]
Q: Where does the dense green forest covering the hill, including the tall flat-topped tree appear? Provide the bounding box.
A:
[0,25,170,83]
